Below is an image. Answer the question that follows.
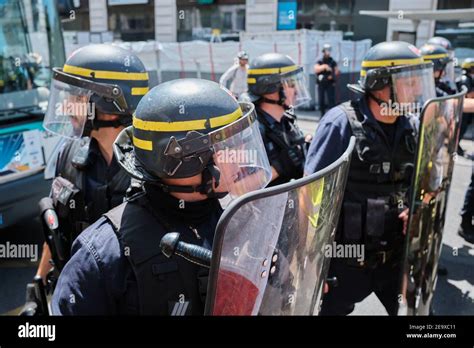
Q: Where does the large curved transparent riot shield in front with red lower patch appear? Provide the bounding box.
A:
[206,138,355,315]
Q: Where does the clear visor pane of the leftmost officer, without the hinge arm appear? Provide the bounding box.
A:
[43,79,94,138]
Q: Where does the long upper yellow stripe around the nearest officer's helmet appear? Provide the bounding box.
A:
[133,107,242,132]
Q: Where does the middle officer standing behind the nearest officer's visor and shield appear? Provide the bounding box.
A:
[243,53,310,186]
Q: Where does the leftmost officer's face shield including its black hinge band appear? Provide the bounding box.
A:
[43,69,127,138]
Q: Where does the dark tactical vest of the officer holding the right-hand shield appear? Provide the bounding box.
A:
[337,101,417,253]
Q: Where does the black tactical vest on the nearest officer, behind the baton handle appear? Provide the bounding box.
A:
[104,194,218,316]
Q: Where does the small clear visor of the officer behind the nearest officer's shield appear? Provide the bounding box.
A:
[281,67,311,107]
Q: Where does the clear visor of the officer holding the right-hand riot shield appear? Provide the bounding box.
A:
[390,63,436,116]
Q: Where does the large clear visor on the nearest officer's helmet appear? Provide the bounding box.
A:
[209,103,271,198]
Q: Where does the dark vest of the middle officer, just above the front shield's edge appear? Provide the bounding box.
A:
[257,108,307,187]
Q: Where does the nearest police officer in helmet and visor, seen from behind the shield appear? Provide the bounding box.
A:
[52,79,271,315]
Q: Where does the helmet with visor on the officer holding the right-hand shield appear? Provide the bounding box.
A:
[347,41,436,113]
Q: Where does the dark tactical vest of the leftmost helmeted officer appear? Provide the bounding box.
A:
[51,138,130,250]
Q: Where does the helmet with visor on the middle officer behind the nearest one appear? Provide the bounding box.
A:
[243,53,310,107]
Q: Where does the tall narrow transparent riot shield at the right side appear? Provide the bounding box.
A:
[399,93,464,315]
